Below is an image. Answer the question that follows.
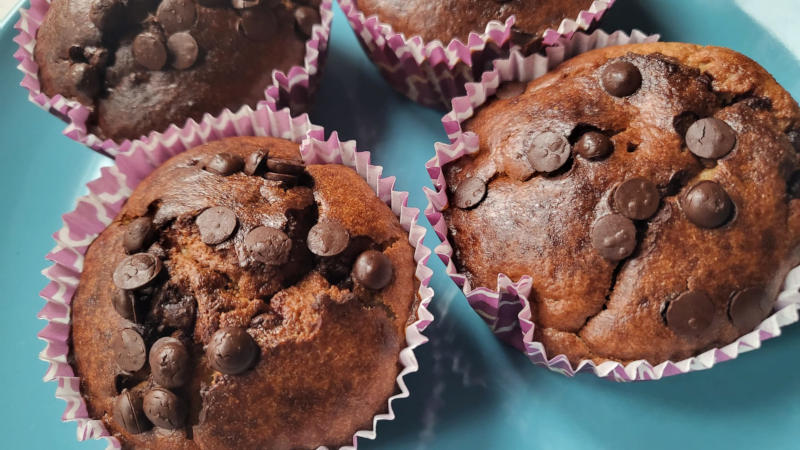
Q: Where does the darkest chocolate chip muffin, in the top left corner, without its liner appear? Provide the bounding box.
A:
[34,0,320,141]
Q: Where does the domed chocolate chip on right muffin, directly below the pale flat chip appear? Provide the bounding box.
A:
[681,180,733,228]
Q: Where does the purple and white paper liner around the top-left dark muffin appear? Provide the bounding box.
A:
[14,0,333,158]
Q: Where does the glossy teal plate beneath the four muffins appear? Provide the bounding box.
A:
[0,0,800,449]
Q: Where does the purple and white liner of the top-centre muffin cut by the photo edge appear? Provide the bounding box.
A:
[339,0,615,109]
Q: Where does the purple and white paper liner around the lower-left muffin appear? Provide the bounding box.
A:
[38,102,433,448]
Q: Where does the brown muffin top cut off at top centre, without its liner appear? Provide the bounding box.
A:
[355,0,592,51]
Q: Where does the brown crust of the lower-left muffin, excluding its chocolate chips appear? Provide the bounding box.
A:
[72,138,417,449]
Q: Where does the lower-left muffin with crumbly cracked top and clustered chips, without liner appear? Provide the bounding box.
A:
[71,138,418,449]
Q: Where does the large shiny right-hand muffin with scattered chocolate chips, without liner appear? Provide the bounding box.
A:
[444,43,800,365]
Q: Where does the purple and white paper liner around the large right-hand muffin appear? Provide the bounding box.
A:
[423,27,800,381]
